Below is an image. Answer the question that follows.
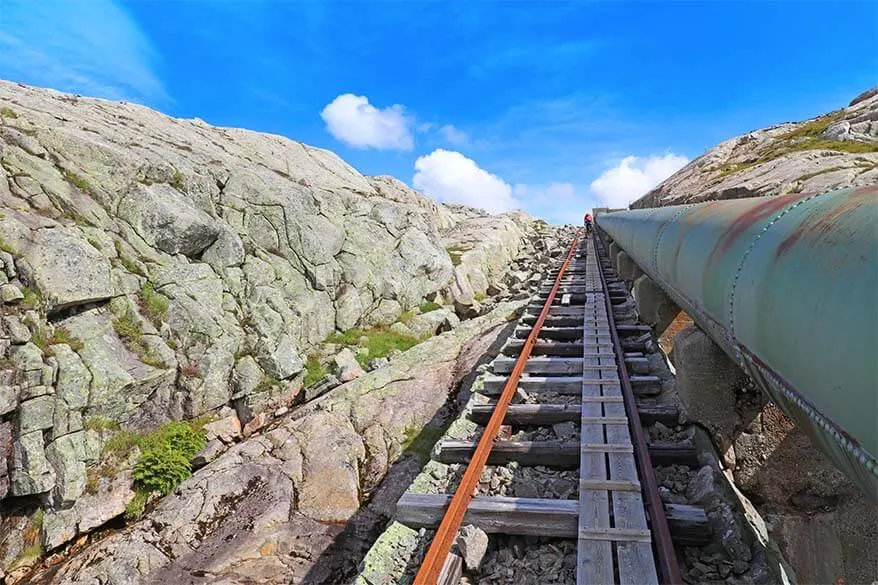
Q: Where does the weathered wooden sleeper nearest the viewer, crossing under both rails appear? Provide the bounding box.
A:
[394,492,711,546]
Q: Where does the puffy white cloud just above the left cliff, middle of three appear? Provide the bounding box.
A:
[412,148,521,213]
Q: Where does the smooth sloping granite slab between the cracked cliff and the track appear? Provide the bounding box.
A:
[51,301,523,585]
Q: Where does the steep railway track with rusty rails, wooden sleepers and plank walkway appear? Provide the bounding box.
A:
[397,234,691,585]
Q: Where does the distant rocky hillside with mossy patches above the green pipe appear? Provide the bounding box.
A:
[631,88,878,209]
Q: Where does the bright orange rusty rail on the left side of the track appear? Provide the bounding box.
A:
[414,232,580,585]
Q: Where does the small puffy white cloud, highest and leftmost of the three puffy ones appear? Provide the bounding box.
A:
[320,93,414,150]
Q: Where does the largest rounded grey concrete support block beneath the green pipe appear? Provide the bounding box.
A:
[674,325,744,469]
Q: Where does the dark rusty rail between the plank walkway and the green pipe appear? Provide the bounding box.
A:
[592,230,683,585]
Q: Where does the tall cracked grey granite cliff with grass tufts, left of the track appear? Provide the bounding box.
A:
[0,82,548,577]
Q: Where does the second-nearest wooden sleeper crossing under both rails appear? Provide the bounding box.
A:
[437,440,699,469]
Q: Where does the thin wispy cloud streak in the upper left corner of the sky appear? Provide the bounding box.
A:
[0,0,172,103]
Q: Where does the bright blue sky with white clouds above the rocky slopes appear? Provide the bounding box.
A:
[0,0,878,221]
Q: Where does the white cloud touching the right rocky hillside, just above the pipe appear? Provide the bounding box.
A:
[591,153,689,207]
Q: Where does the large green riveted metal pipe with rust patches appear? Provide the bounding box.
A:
[596,186,878,502]
